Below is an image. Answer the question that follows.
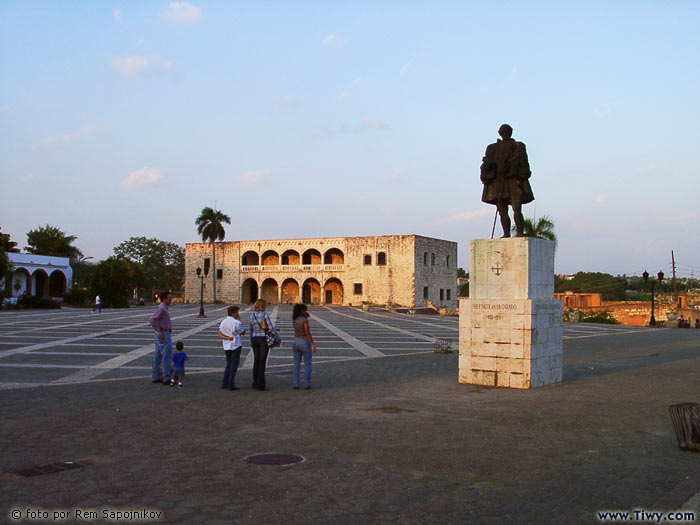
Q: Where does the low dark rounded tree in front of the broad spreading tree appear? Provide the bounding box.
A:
[90,257,146,308]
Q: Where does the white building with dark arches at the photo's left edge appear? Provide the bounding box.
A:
[0,253,73,299]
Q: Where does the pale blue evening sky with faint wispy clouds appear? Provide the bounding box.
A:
[0,0,700,278]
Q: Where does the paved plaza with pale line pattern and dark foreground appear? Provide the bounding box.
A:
[0,305,700,523]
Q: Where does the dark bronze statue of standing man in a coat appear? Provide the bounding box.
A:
[481,124,535,237]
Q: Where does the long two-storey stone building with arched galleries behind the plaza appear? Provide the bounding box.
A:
[185,235,458,310]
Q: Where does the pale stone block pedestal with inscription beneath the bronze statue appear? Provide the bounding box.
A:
[459,237,563,388]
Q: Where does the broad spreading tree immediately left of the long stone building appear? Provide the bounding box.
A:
[113,237,185,295]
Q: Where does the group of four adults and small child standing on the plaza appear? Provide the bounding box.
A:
[148,292,316,390]
